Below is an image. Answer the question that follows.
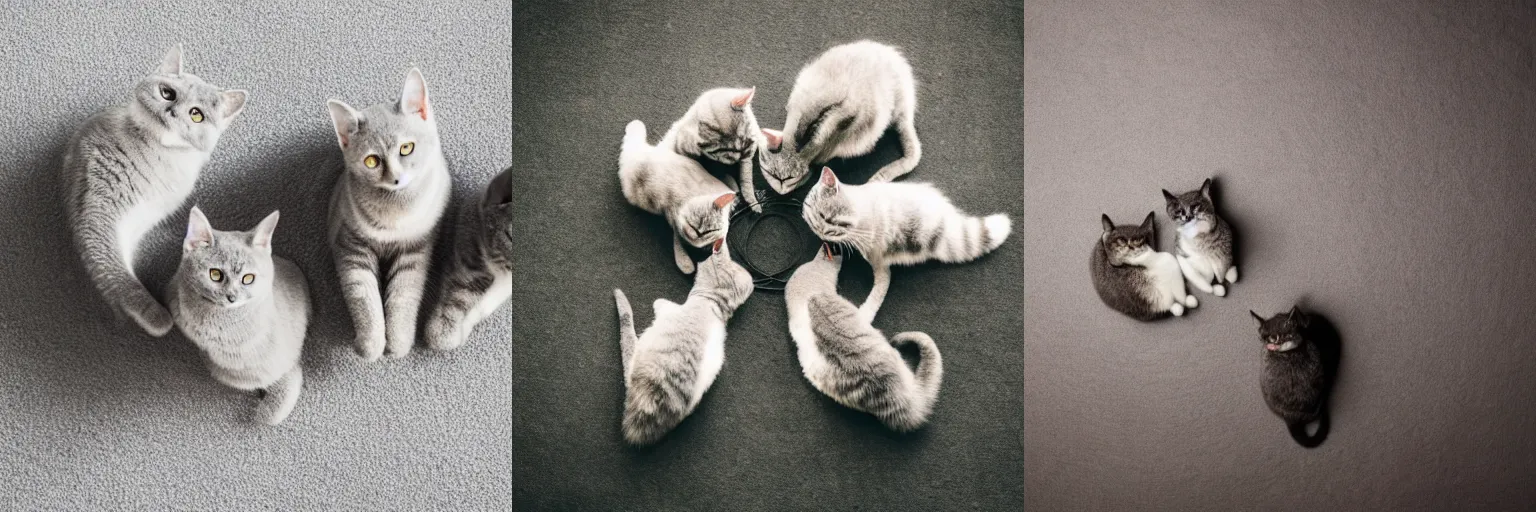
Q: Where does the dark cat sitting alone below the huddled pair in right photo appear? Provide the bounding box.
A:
[1249,306,1332,447]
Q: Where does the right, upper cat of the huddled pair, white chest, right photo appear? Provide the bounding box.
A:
[1163,178,1238,297]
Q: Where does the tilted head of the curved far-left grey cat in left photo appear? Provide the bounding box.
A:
[132,45,246,152]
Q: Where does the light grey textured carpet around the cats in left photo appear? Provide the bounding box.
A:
[0,0,511,510]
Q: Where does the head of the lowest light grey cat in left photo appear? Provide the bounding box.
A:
[177,206,278,308]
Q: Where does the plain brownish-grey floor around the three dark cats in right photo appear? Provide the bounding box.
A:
[1021,0,1536,510]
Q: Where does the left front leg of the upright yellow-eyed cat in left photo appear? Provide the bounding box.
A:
[333,243,384,361]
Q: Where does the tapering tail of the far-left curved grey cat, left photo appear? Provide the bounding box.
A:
[75,226,175,338]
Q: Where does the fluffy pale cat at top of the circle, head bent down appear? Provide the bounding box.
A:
[742,40,923,195]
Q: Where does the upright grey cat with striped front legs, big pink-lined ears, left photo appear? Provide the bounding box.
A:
[329,68,452,361]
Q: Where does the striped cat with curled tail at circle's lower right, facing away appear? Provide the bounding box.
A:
[783,244,945,432]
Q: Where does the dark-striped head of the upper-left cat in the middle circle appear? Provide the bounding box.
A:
[677,88,757,165]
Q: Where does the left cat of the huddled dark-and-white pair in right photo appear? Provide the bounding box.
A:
[1089,212,1200,321]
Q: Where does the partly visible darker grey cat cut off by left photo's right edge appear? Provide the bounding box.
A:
[427,168,511,351]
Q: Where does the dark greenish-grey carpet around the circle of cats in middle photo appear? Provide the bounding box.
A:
[513,2,1023,510]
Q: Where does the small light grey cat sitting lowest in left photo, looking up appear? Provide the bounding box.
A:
[166,206,309,424]
